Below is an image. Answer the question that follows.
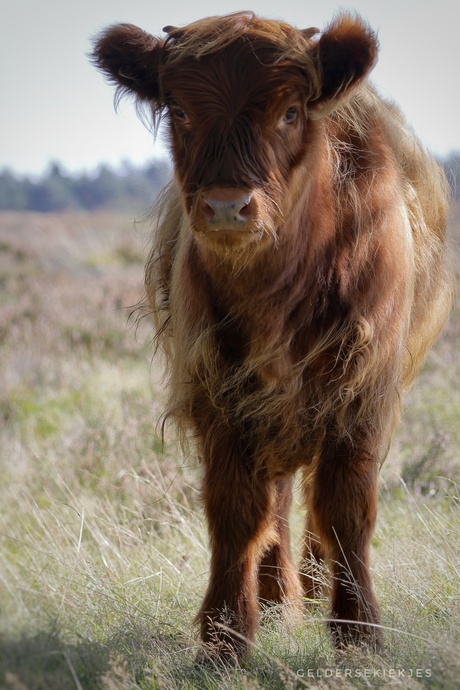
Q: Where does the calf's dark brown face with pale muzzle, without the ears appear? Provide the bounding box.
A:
[162,46,309,250]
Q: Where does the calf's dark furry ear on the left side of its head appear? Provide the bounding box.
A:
[90,24,164,100]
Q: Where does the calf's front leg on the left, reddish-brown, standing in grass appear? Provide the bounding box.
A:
[197,436,276,658]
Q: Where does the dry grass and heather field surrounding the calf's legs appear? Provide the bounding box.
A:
[0,209,460,690]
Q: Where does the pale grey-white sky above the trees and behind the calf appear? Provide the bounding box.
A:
[0,0,460,175]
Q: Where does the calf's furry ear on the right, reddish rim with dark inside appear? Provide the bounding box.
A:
[310,14,378,117]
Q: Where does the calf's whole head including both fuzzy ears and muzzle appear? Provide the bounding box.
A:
[92,13,377,252]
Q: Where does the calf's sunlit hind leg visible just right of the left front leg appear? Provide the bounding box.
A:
[259,479,301,604]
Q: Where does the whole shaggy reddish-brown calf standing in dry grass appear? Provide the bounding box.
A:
[93,13,451,657]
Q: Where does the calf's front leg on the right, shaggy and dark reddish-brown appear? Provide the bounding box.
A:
[311,442,382,647]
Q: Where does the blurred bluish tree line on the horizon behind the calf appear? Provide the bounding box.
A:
[0,153,460,212]
